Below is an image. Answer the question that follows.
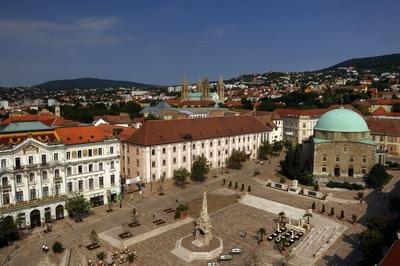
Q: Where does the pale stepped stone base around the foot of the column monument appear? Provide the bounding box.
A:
[170,235,224,262]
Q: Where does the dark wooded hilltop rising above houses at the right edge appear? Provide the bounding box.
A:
[322,54,400,70]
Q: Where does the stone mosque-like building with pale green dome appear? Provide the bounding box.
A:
[308,107,383,177]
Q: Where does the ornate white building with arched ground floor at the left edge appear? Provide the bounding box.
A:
[0,121,120,228]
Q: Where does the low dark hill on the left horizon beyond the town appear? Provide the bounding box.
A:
[35,78,161,90]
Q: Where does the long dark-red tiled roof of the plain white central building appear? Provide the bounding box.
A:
[126,116,269,146]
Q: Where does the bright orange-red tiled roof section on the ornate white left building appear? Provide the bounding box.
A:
[55,126,113,145]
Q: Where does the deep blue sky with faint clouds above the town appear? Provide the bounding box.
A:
[0,0,400,86]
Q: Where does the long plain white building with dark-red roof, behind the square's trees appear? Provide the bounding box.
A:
[121,116,271,182]
